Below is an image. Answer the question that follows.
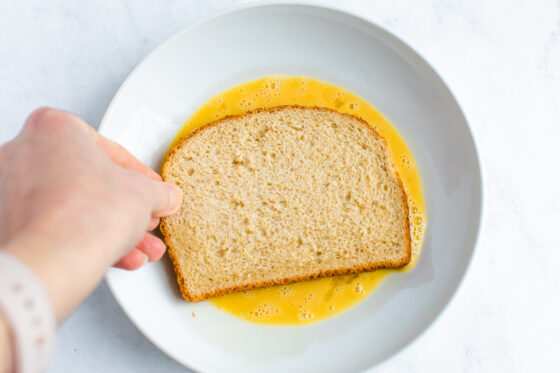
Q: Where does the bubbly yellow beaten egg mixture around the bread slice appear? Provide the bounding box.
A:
[166,75,426,325]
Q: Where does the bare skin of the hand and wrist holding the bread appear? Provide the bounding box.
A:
[0,108,182,372]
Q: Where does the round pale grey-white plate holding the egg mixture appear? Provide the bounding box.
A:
[100,5,482,372]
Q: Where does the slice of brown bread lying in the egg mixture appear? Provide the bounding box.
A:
[161,106,411,301]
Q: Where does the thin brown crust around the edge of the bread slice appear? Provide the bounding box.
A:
[160,105,412,302]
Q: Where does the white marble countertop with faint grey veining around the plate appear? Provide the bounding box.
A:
[0,0,560,372]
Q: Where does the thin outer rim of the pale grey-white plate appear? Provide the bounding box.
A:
[97,0,487,371]
